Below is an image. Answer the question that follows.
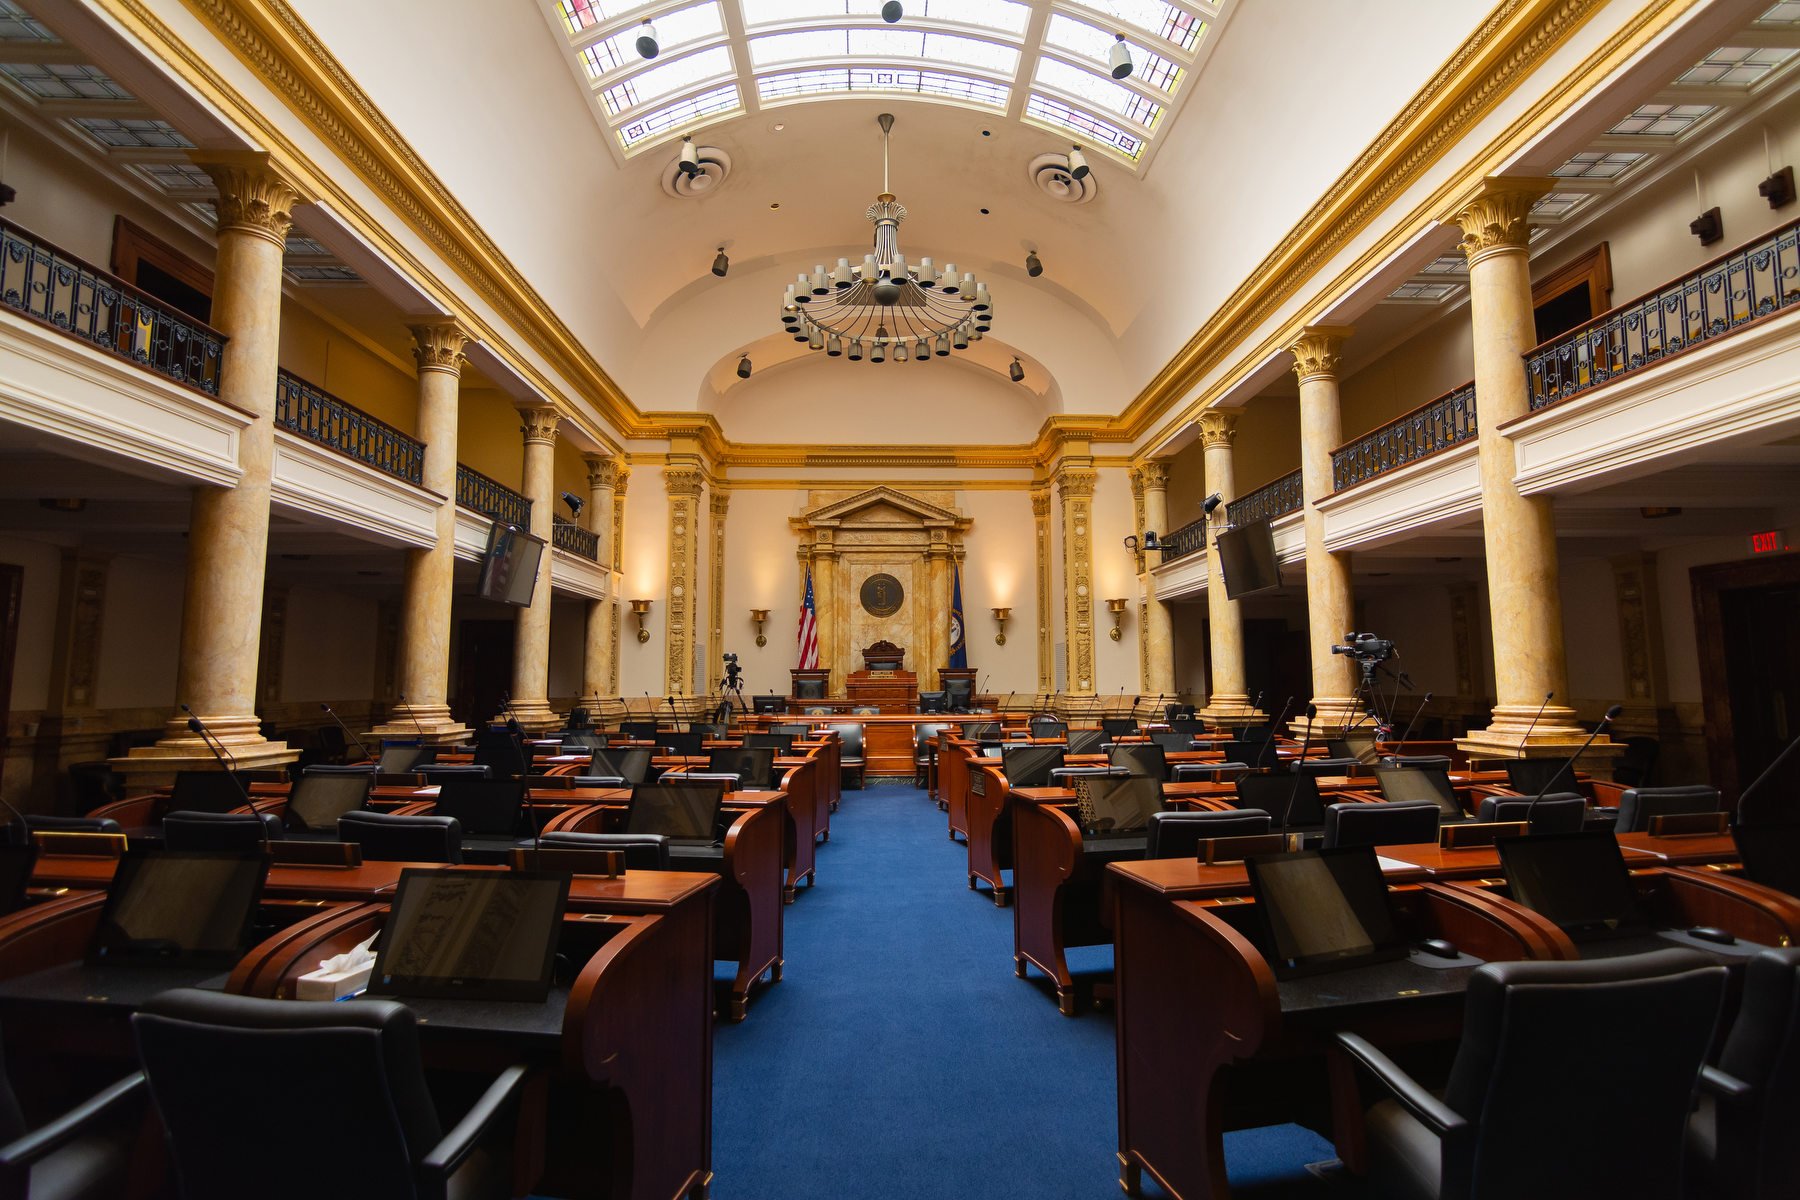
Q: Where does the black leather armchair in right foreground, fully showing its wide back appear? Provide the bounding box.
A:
[1337,950,1726,1200]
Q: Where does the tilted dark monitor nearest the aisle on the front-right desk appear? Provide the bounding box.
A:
[1244,846,1408,979]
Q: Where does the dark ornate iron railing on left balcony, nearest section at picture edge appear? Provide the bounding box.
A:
[0,221,225,396]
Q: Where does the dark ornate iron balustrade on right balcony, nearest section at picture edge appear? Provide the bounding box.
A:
[1525,223,1800,410]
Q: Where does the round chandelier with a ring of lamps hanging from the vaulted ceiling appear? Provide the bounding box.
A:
[781,113,994,362]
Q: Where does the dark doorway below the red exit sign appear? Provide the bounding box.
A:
[1688,554,1800,820]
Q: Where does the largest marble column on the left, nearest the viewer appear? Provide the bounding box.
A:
[113,153,299,790]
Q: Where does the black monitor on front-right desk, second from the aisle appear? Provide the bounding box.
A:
[1496,829,1651,941]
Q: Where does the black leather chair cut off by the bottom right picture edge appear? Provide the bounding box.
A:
[1687,948,1800,1200]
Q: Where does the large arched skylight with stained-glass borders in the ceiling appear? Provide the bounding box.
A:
[540,0,1229,166]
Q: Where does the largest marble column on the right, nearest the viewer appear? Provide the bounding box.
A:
[1447,178,1609,757]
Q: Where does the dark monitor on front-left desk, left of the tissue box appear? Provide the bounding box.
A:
[88,849,268,966]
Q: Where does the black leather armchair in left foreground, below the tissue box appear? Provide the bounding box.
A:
[131,988,527,1200]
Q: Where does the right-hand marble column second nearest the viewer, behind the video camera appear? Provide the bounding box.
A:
[1289,326,1361,739]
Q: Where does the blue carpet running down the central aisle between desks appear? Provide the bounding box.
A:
[713,784,1337,1200]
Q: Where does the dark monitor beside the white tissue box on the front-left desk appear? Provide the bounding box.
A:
[369,867,569,1002]
